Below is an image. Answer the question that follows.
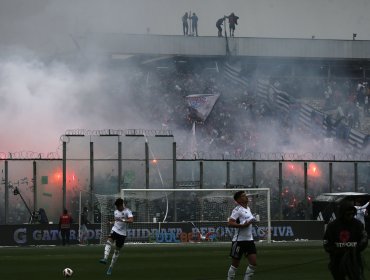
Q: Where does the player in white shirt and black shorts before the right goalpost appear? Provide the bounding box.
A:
[227,191,257,280]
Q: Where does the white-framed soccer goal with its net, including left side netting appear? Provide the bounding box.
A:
[79,188,271,244]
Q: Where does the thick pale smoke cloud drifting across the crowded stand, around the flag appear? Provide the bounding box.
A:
[0,46,364,158]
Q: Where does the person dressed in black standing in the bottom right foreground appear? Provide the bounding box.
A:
[323,201,368,280]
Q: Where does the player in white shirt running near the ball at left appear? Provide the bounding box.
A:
[99,198,134,275]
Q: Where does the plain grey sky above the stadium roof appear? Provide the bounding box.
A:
[0,0,370,51]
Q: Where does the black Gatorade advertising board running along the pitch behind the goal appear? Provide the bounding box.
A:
[0,221,324,246]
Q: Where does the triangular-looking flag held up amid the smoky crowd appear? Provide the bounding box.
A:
[185,94,220,122]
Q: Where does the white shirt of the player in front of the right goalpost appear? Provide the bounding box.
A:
[230,205,254,241]
